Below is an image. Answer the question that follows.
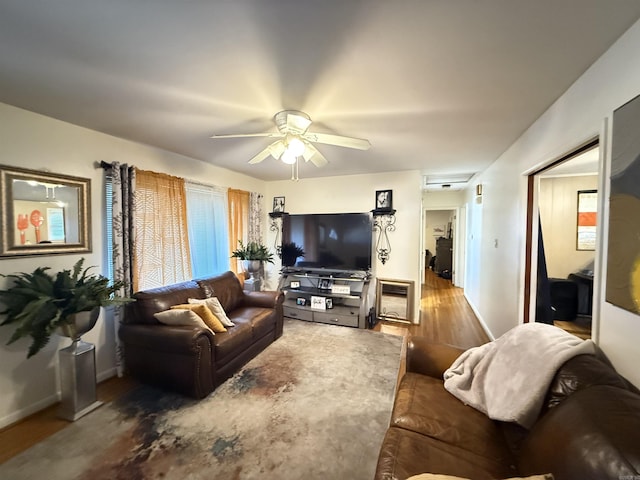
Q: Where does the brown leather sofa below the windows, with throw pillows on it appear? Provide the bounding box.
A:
[119,272,283,398]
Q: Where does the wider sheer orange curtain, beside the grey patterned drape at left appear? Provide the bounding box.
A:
[133,169,191,291]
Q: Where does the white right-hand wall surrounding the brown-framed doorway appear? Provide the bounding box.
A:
[465,22,640,385]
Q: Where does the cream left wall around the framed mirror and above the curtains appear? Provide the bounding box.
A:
[0,104,264,427]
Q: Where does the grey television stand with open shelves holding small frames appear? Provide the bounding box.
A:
[278,269,374,328]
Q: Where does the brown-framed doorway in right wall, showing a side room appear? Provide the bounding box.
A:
[524,139,601,338]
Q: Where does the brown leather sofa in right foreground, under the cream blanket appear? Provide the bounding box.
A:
[375,337,640,480]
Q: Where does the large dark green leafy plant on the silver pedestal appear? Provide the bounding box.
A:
[0,258,131,358]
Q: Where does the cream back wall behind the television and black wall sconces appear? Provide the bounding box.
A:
[265,171,423,319]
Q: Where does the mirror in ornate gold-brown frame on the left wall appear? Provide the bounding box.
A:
[0,165,91,258]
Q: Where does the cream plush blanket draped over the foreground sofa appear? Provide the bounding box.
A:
[444,323,595,428]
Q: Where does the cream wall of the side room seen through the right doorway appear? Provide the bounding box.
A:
[538,175,598,278]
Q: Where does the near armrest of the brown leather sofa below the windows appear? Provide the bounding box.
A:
[119,324,214,398]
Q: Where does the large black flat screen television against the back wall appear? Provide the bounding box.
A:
[282,213,373,271]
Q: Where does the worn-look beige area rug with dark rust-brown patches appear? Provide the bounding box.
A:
[0,320,402,480]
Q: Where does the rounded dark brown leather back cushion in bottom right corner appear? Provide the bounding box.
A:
[518,385,640,480]
